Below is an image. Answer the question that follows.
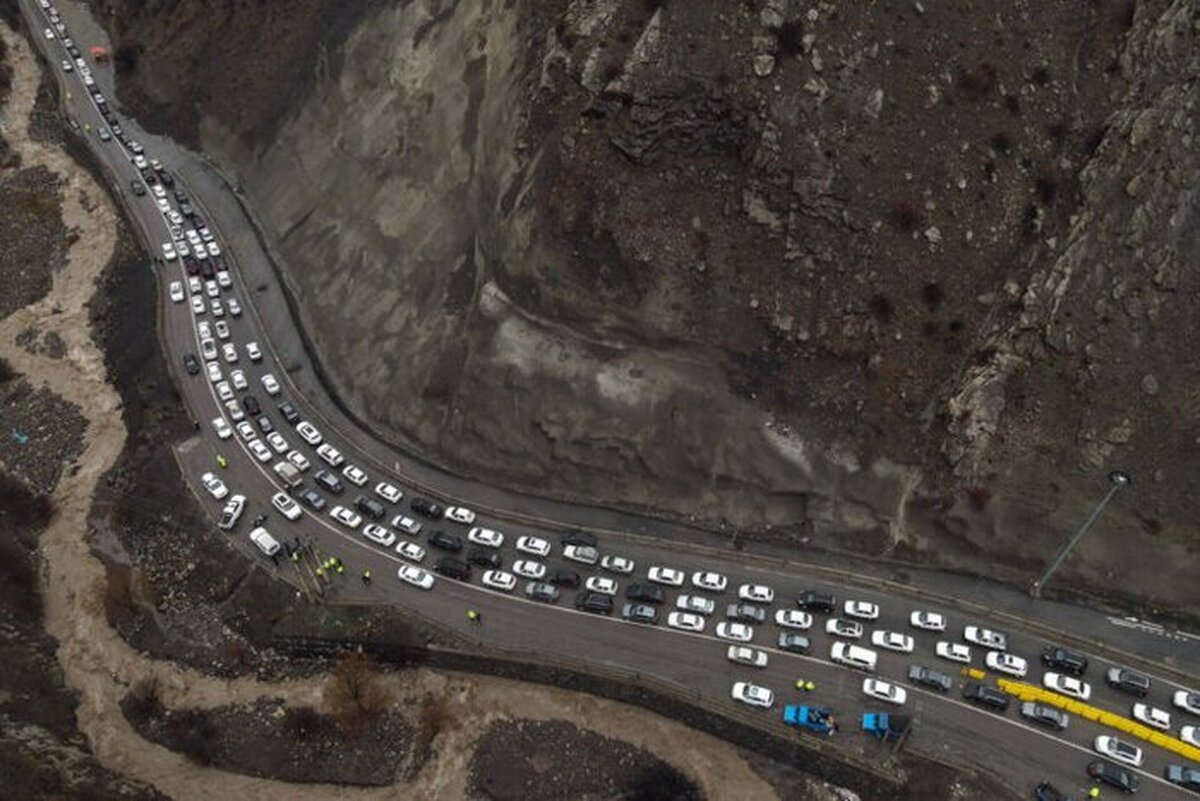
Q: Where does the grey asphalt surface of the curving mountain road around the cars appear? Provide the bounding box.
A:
[23,0,1200,797]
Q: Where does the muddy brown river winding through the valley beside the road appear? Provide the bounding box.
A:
[0,24,775,801]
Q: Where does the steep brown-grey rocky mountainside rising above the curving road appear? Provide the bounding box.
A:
[96,0,1200,609]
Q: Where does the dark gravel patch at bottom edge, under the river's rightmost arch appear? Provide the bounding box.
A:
[468,721,702,801]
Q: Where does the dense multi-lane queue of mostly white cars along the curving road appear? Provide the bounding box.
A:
[32,0,1200,797]
